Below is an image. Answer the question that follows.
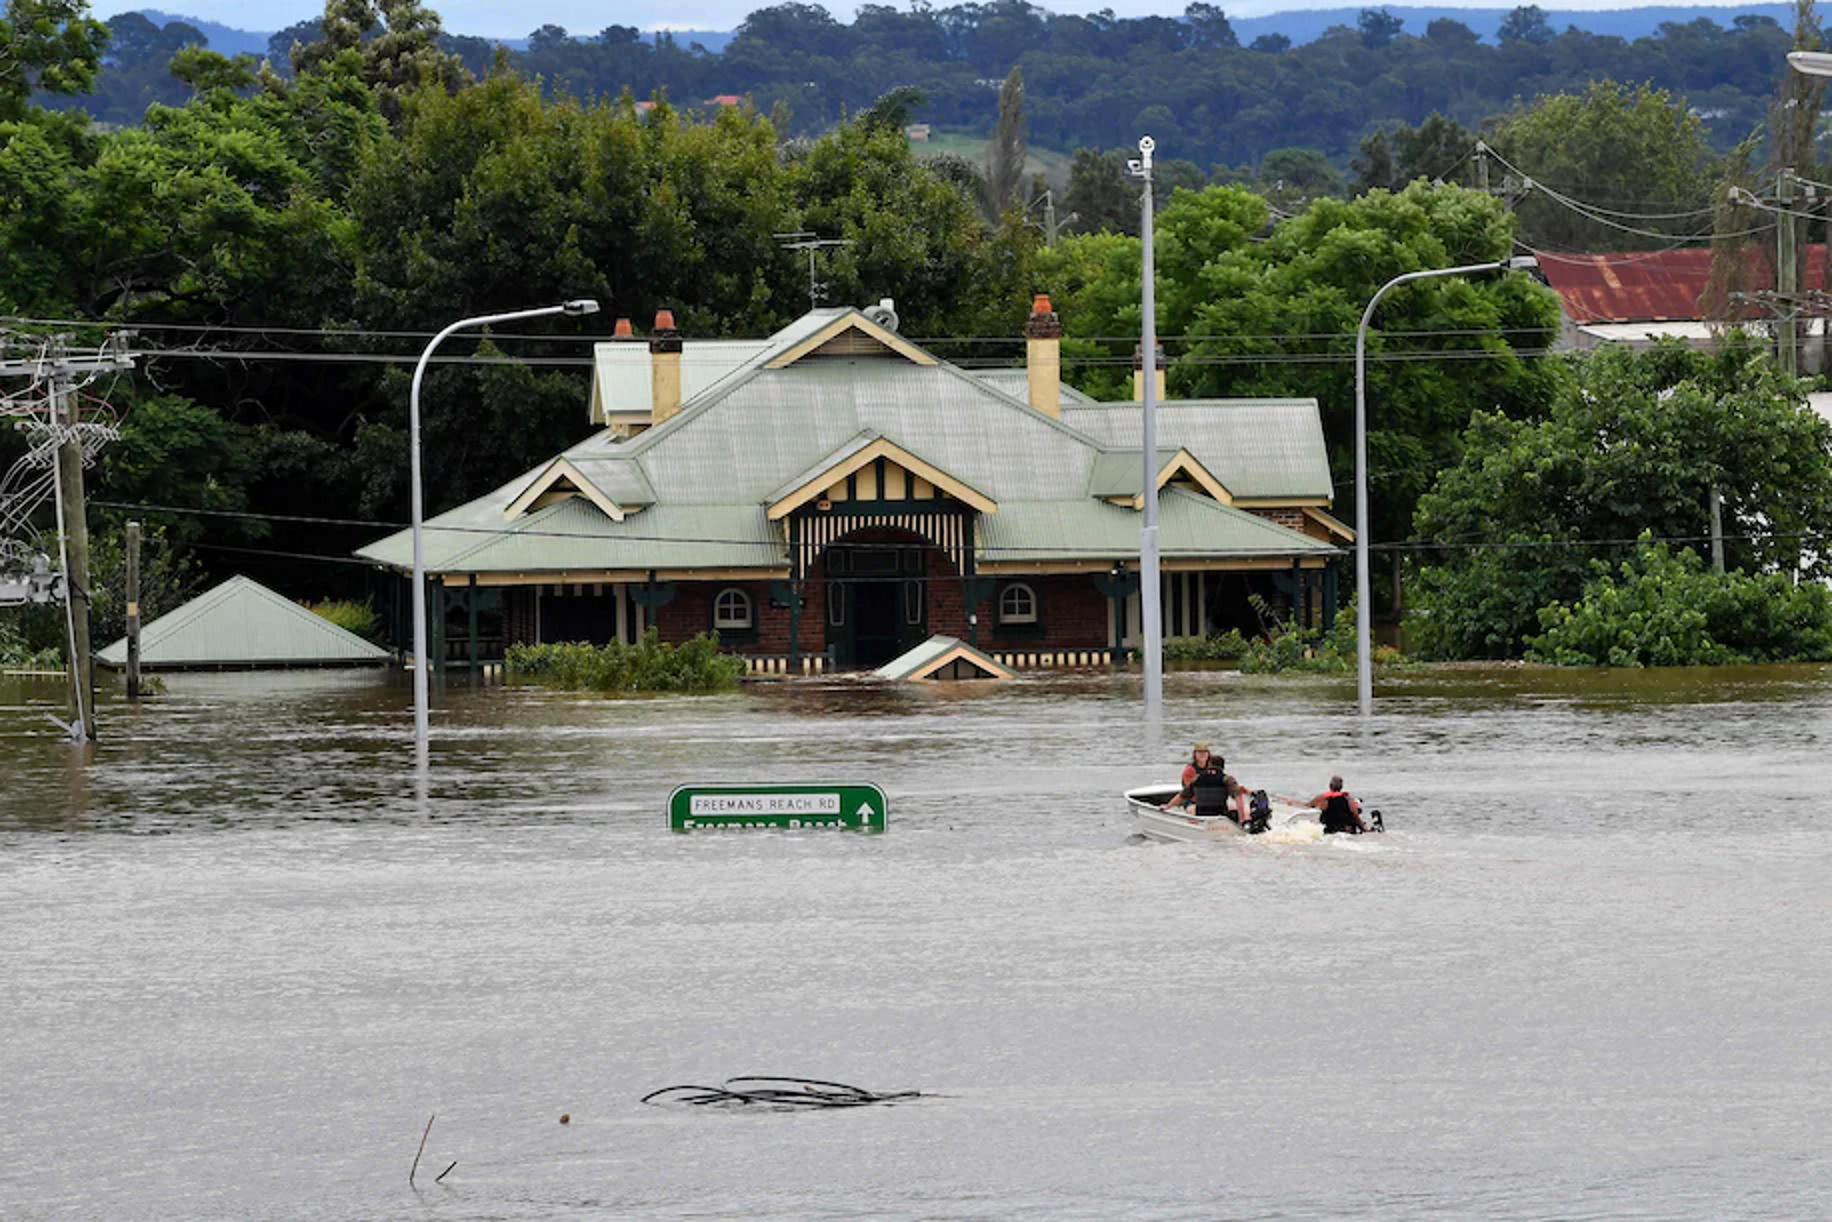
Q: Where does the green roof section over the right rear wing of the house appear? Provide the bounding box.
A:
[1063,399,1334,500]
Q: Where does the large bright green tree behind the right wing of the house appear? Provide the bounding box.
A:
[1041,183,1559,539]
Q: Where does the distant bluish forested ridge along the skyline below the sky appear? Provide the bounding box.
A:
[57,0,1790,165]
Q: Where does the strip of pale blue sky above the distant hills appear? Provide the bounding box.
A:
[92,0,1773,38]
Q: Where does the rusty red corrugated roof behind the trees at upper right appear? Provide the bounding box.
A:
[1539,245,1827,322]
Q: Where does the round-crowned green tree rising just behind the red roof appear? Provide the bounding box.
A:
[1489,81,1718,251]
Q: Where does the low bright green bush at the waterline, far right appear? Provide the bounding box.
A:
[1526,535,1832,667]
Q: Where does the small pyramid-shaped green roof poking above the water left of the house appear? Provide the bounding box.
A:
[97,577,388,669]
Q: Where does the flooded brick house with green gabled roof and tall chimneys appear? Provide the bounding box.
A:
[357,297,1350,672]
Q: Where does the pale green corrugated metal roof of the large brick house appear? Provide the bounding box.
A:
[357,310,1330,573]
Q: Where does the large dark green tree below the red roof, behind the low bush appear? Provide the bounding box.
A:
[1407,344,1832,658]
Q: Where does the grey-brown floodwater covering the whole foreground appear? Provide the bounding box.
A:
[0,669,1832,1218]
